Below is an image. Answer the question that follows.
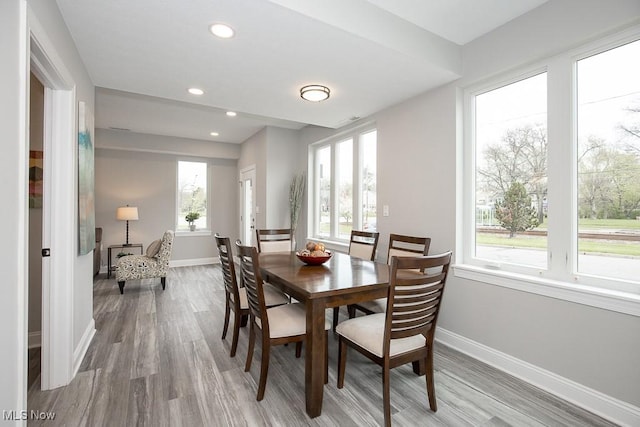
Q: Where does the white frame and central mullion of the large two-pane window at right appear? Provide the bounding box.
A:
[453,26,640,316]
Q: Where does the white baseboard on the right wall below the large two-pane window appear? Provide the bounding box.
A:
[436,327,640,427]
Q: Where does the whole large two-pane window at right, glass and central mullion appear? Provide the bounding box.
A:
[461,34,640,294]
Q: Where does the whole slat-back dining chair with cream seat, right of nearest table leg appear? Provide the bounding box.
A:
[336,252,451,426]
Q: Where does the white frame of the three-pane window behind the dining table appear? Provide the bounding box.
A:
[307,122,377,246]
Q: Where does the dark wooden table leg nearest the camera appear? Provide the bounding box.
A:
[304,299,326,418]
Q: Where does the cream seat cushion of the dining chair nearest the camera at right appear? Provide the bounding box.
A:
[336,313,426,357]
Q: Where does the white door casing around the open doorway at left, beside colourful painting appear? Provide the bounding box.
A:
[25,8,77,390]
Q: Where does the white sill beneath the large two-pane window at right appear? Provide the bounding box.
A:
[453,264,640,317]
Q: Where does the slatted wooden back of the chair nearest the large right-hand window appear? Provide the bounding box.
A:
[385,252,451,345]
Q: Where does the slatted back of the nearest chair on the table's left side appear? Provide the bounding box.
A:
[236,241,269,334]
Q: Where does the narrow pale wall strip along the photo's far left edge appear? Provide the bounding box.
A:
[0,0,28,425]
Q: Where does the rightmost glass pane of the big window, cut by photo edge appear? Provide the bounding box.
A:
[577,41,640,281]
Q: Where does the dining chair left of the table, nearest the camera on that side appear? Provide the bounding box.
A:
[236,242,331,400]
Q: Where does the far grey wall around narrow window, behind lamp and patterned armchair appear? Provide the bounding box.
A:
[96,129,239,266]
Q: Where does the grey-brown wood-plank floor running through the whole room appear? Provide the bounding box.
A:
[29,265,613,427]
